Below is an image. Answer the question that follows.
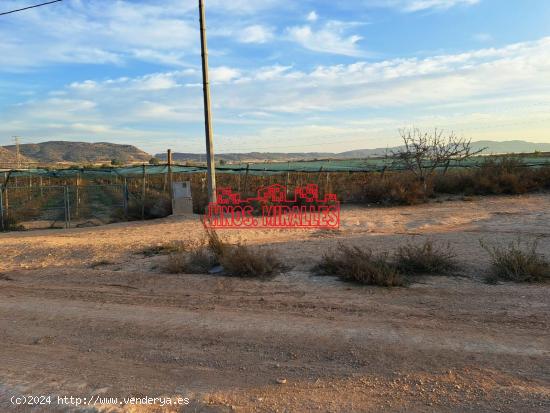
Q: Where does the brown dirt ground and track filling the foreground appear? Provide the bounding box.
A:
[0,194,550,413]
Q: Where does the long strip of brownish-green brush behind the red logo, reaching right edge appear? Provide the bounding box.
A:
[183,152,550,209]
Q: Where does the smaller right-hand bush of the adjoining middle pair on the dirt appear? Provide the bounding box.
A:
[394,240,458,275]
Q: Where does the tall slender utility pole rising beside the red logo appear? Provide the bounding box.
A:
[199,0,217,203]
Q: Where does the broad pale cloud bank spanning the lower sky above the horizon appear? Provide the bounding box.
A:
[0,38,550,150]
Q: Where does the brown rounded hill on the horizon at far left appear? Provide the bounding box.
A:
[3,141,151,163]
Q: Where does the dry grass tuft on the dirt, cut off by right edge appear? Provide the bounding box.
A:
[480,239,550,283]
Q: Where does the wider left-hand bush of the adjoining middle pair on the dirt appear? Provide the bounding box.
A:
[316,244,405,287]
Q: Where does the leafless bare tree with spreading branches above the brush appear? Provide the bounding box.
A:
[388,128,486,189]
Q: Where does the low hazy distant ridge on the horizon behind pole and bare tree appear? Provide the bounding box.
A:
[160,141,550,162]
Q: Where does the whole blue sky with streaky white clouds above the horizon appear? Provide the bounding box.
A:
[0,0,550,153]
